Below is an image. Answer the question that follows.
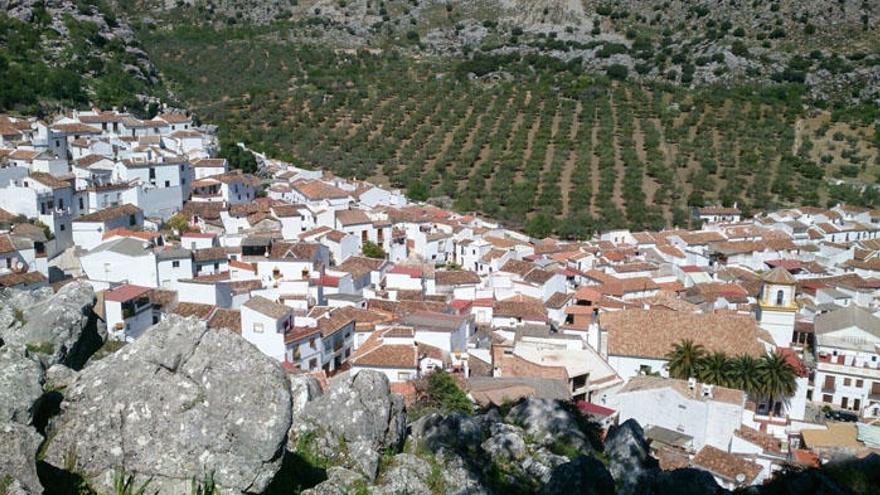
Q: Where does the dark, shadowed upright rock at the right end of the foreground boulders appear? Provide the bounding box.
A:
[605,419,659,494]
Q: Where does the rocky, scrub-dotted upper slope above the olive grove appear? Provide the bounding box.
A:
[119,0,880,102]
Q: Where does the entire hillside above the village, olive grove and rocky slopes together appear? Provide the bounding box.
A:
[0,0,880,237]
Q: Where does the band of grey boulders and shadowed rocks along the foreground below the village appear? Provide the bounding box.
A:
[0,283,880,495]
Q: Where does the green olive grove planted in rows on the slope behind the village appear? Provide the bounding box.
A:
[142,25,880,236]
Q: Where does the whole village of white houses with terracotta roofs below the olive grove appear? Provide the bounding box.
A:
[0,110,880,488]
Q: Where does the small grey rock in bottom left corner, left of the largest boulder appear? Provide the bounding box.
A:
[0,423,43,493]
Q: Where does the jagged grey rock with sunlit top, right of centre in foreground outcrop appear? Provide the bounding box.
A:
[506,398,592,453]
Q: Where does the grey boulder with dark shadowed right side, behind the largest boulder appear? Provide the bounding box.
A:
[3,282,99,368]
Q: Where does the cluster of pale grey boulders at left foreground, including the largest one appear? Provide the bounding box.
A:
[0,283,293,494]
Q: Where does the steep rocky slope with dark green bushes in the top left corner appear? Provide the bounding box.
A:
[0,0,161,113]
